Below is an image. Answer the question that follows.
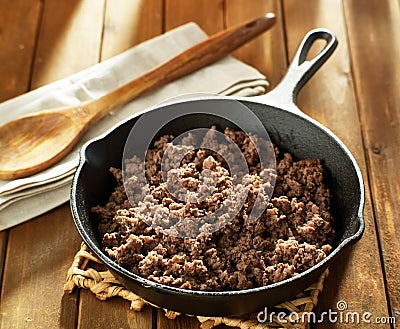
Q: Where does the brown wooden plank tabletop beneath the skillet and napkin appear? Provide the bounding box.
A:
[0,0,400,329]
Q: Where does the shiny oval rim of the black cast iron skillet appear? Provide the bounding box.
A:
[70,96,365,298]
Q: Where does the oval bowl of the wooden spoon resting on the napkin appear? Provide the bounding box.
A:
[0,111,84,179]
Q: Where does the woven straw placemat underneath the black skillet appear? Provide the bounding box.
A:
[64,243,328,329]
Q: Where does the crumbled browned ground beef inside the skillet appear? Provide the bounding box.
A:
[93,125,334,291]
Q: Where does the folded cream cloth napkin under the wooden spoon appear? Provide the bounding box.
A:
[0,23,268,230]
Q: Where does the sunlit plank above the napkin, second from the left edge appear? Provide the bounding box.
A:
[32,0,104,88]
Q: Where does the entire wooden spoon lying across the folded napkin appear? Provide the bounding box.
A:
[0,14,275,179]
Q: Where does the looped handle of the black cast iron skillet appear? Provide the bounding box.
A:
[254,28,338,112]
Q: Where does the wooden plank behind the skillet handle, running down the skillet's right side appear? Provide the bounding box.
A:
[284,0,387,328]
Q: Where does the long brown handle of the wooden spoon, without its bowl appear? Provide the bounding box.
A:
[83,13,275,126]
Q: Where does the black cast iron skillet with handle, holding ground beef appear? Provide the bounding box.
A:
[71,29,364,316]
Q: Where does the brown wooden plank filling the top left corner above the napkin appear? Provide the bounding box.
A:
[0,0,41,102]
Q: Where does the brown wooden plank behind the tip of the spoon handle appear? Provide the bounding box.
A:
[225,0,287,87]
